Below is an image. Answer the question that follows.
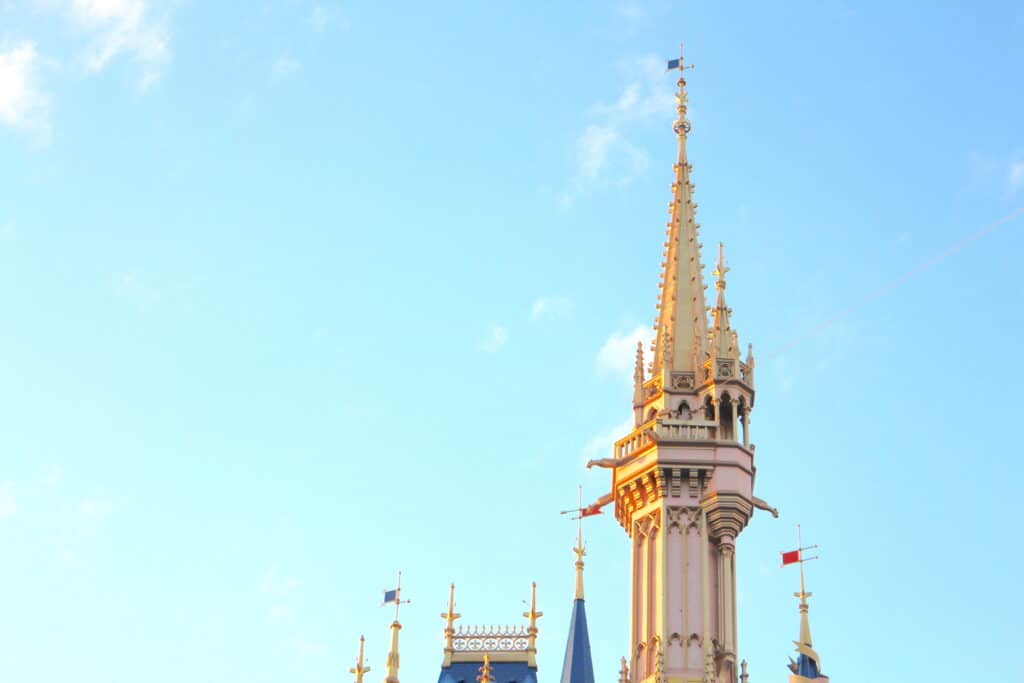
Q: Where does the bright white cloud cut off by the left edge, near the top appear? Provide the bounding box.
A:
[0,41,50,142]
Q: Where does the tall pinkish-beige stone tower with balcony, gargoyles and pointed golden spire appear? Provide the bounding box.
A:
[595,58,774,683]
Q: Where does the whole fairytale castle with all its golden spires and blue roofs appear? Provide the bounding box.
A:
[351,53,828,683]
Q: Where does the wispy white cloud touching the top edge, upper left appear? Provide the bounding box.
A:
[52,0,171,90]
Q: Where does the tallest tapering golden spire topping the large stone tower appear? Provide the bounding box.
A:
[652,48,708,387]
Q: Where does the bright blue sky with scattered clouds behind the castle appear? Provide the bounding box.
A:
[0,0,1024,683]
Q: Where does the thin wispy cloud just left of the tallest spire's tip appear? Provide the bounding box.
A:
[561,55,674,207]
